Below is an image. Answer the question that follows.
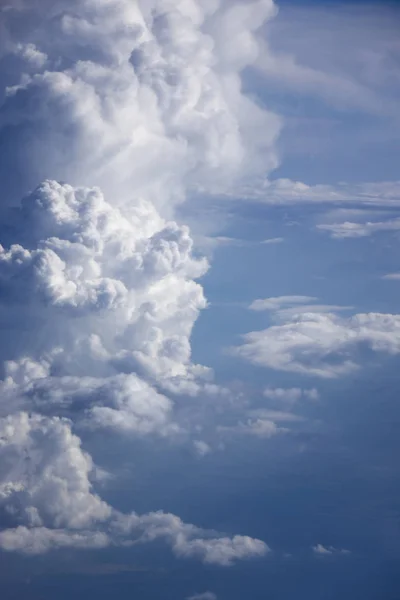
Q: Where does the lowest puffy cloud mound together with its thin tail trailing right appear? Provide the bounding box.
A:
[0,413,268,566]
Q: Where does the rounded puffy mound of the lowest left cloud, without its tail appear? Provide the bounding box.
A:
[0,413,111,530]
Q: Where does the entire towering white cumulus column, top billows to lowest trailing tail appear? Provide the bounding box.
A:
[0,0,279,565]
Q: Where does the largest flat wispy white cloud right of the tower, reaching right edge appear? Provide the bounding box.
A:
[231,312,400,378]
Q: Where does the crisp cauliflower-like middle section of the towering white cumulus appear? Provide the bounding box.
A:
[0,181,207,384]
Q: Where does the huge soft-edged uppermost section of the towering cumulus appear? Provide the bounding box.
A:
[0,0,279,211]
